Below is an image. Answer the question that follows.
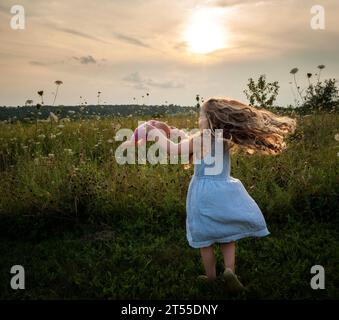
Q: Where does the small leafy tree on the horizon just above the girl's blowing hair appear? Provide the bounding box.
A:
[244,75,280,108]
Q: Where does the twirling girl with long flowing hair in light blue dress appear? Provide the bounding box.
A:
[147,97,296,291]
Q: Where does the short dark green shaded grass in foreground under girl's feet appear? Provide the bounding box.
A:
[0,218,339,299]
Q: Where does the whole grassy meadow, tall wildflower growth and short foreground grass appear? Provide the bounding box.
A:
[0,114,339,299]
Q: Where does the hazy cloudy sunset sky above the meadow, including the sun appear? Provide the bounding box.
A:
[0,0,339,105]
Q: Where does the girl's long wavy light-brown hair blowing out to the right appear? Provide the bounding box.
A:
[202,97,297,155]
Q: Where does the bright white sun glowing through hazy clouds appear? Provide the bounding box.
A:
[184,8,227,54]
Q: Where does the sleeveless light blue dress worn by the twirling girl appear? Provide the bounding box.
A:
[186,139,270,248]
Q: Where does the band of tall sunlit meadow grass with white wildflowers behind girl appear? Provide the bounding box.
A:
[0,114,339,221]
